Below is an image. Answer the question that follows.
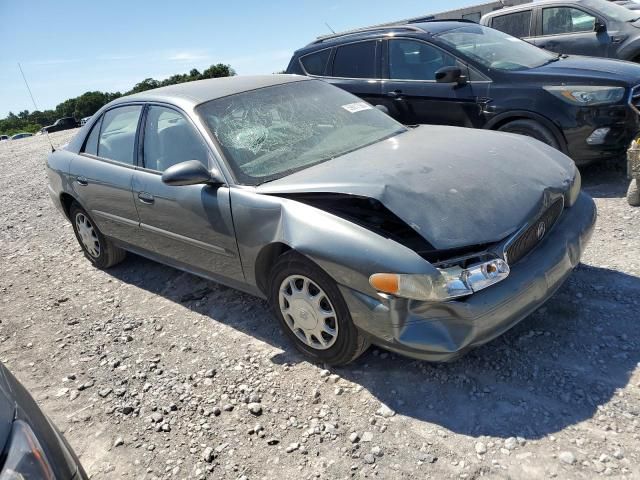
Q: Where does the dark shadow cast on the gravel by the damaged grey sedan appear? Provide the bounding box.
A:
[109,255,640,439]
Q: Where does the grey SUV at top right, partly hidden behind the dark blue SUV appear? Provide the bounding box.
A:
[480,0,640,62]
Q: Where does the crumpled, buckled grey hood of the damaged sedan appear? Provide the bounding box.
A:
[257,126,575,249]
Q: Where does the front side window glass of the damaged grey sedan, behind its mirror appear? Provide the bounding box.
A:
[143,105,209,172]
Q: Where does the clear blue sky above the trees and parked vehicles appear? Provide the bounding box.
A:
[0,0,482,117]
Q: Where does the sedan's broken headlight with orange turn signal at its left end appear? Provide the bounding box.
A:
[369,259,509,301]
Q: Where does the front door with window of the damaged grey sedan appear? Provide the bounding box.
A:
[133,105,244,281]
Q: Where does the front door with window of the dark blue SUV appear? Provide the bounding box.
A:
[382,38,482,127]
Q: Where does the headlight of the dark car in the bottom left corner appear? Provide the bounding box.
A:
[0,420,55,480]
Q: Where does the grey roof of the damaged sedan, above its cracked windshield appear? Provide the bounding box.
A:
[111,75,309,107]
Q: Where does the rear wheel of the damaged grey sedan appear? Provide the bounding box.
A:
[69,202,127,268]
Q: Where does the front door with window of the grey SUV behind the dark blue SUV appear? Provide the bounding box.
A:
[534,5,611,57]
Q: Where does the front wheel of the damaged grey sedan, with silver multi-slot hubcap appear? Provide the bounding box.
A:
[269,252,369,366]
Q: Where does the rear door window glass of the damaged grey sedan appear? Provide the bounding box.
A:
[98,105,142,165]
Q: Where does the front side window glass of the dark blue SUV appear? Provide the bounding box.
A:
[389,39,457,81]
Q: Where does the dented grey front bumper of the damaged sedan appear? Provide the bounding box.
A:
[340,193,596,361]
